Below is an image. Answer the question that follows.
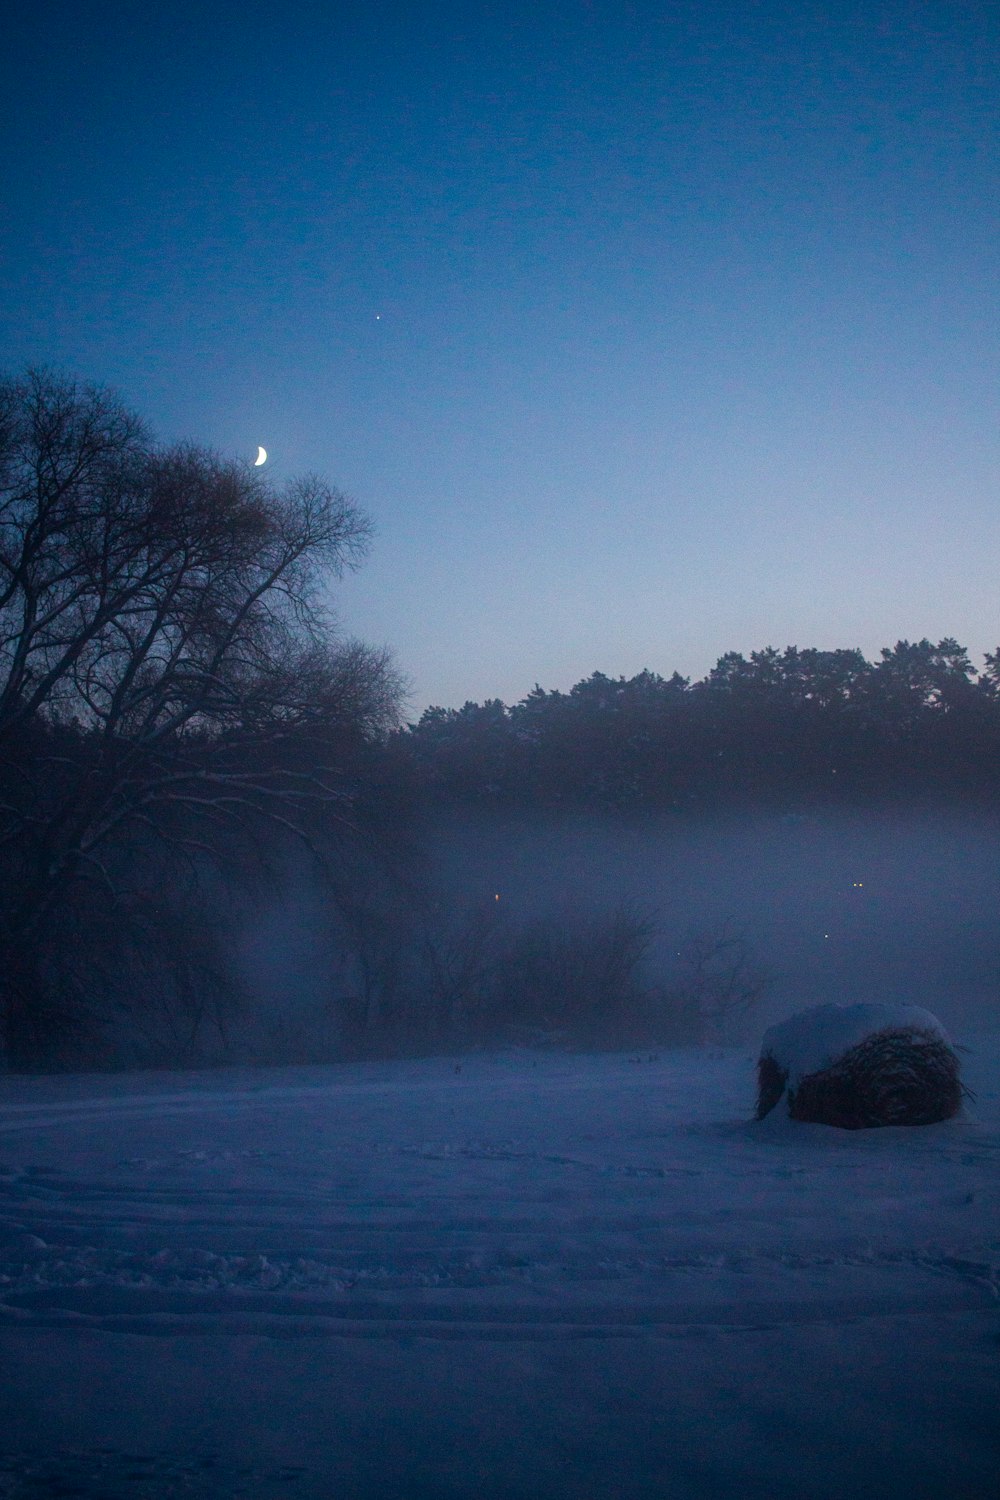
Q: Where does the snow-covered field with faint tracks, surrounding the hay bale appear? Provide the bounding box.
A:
[0,1034,1000,1500]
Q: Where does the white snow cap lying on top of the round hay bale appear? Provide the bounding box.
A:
[760,1004,951,1089]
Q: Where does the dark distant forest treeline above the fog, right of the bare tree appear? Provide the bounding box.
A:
[399,639,1000,812]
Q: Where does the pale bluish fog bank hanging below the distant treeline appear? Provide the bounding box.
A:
[243,809,1000,1061]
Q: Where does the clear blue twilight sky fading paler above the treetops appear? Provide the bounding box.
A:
[0,0,1000,714]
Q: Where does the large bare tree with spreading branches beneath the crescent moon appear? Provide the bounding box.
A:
[0,372,400,1062]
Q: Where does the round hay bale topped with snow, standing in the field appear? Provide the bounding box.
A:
[757,1005,963,1130]
